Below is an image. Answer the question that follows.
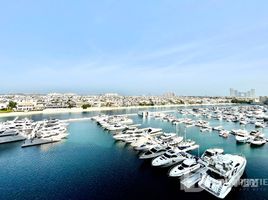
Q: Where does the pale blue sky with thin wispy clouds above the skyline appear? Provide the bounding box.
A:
[0,0,268,95]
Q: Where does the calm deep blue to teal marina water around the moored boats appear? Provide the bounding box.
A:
[0,109,268,200]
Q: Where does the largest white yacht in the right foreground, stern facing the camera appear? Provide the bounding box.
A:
[198,154,247,199]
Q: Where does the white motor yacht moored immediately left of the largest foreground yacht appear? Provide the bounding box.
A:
[169,158,201,177]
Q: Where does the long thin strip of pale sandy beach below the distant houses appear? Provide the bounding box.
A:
[0,103,235,118]
